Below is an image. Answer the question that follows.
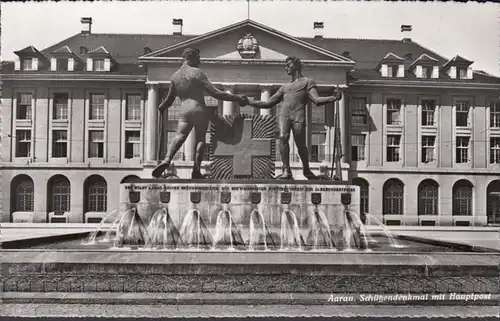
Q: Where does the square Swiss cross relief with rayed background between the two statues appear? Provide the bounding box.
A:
[210,115,276,179]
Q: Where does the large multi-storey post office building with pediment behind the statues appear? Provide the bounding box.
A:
[0,18,500,226]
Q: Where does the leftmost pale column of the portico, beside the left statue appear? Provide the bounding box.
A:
[144,84,158,162]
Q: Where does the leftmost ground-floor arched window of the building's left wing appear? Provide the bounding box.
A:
[10,174,35,213]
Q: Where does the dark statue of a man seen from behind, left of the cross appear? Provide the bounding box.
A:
[153,48,248,178]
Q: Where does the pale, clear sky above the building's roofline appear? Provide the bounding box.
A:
[0,0,500,76]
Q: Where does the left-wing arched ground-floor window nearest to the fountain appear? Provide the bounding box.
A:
[83,175,108,213]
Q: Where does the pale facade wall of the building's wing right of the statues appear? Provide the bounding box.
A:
[346,87,500,225]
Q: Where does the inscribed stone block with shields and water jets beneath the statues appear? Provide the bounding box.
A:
[120,179,361,249]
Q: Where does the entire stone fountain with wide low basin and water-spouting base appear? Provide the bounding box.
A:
[0,116,499,318]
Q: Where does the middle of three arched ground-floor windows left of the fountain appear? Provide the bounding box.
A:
[47,175,71,213]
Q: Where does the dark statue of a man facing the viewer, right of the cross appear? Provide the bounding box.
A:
[249,57,342,179]
